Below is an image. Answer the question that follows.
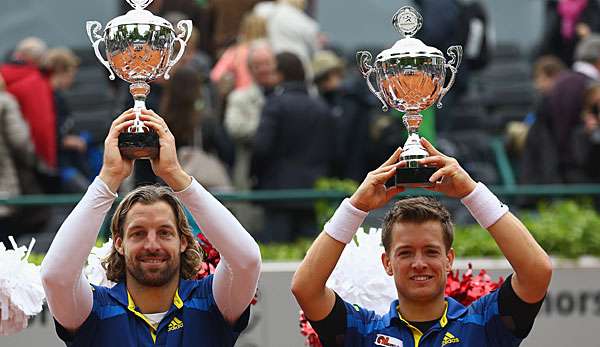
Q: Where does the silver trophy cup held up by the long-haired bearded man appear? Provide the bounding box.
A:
[86,0,192,159]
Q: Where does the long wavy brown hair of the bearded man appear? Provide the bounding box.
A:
[102,186,202,282]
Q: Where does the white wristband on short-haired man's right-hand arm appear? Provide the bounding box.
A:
[460,182,508,229]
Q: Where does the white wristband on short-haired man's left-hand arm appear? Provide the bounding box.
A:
[323,198,369,244]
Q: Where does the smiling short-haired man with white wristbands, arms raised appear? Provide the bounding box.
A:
[292,139,552,347]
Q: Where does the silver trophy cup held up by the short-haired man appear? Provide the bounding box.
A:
[356,6,462,187]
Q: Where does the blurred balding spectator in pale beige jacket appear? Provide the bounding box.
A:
[225,40,277,190]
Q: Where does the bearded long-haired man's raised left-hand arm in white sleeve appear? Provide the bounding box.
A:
[41,111,134,332]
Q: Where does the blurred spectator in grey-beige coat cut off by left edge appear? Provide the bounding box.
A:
[0,78,36,245]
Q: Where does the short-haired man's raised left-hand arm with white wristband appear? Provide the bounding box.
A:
[292,148,402,321]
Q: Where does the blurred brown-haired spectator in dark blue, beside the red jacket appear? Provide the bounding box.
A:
[42,48,92,193]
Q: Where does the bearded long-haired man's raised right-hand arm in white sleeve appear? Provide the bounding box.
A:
[142,111,261,325]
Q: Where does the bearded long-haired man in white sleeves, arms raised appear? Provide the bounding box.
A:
[41,110,261,346]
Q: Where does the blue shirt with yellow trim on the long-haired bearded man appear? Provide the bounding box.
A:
[55,275,250,347]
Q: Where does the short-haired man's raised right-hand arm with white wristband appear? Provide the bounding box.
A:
[422,139,552,303]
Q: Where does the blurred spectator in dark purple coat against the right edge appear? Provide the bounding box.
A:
[522,35,600,183]
